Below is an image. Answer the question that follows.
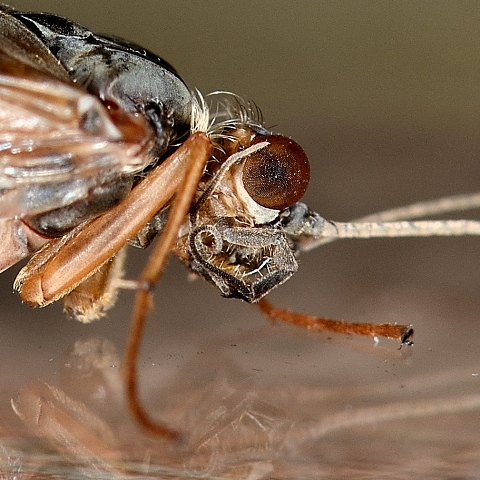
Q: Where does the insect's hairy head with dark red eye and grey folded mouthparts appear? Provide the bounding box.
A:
[176,95,310,302]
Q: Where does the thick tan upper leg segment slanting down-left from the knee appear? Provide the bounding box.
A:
[14,133,210,306]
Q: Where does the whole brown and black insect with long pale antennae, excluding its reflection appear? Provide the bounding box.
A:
[0,5,480,438]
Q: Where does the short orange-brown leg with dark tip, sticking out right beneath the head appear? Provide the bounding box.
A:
[257,298,414,347]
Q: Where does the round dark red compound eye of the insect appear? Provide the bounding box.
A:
[242,135,310,210]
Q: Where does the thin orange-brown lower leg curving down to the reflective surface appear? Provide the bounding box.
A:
[125,134,212,440]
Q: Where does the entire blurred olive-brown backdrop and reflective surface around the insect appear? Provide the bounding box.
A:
[0,1,480,479]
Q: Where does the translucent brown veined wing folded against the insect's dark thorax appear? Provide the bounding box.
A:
[0,11,154,217]
